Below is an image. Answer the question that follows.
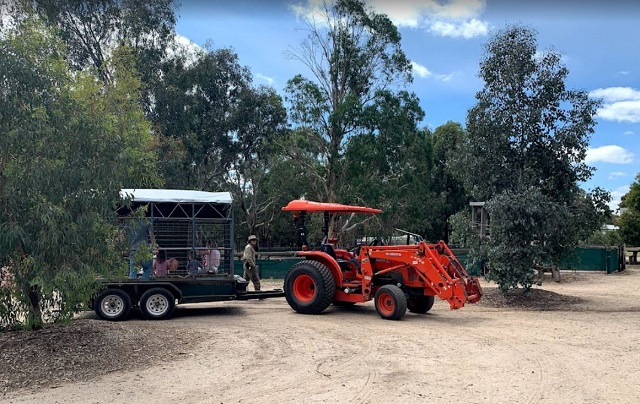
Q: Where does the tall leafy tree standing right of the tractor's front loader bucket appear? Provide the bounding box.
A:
[453,26,610,290]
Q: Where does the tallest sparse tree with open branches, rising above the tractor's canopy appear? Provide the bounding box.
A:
[286,0,411,202]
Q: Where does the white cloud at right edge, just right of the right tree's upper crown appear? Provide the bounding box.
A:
[589,87,640,123]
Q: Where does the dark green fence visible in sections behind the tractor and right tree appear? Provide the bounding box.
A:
[240,246,623,279]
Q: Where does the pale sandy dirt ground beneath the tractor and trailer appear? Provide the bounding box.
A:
[0,267,640,404]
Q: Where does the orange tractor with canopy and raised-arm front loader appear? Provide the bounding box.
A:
[282,200,482,320]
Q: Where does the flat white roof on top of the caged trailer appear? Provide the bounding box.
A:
[120,188,232,204]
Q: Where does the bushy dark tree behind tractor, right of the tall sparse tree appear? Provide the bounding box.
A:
[339,91,433,236]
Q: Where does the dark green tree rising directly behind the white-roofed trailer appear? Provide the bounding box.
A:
[150,45,287,237]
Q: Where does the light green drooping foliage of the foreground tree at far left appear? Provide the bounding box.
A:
[0,20,157,328]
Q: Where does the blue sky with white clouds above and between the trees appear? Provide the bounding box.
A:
[176,0,640,209]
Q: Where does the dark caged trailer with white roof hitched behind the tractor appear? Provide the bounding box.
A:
[91,189,284,321]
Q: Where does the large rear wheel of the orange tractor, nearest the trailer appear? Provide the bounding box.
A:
[284,260,336,314]
